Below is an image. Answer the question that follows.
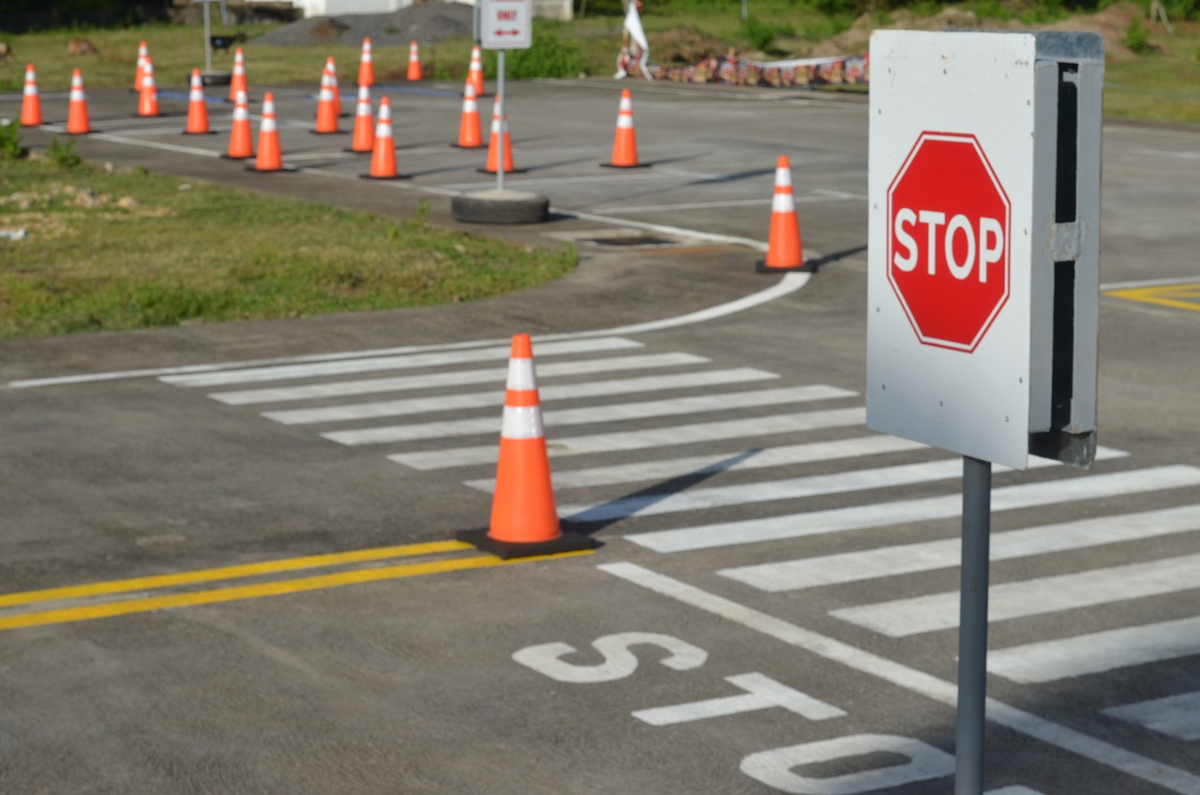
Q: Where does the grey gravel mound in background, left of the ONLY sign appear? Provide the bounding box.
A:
[254,2,474,47]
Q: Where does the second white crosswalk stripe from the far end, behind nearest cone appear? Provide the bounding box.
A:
[209,353,712,406]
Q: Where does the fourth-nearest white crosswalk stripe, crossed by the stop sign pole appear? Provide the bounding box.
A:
[718,506,1200,593]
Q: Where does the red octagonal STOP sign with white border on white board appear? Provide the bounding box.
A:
[887,132,1010,353]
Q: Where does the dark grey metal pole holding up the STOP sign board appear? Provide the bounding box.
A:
[954,456,991,795]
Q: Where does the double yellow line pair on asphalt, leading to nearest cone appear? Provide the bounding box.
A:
[0,542,593,630]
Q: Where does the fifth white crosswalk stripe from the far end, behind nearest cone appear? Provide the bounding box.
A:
[388,408,866,470]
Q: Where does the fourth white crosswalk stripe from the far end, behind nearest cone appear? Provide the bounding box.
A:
[322,384,856,446]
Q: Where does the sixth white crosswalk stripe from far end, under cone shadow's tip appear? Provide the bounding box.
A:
[464,434,929,491]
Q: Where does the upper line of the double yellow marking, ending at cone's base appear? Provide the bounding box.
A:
[0,542,474,608]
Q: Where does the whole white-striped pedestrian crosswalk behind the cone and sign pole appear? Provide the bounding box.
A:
[161,336,1200,741]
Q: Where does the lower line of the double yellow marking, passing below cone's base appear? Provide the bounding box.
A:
[0,544,595,630]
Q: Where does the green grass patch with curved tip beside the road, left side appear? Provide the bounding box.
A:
[0,159,576,339]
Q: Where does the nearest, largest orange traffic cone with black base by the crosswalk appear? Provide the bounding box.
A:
[457,334,596,558]
